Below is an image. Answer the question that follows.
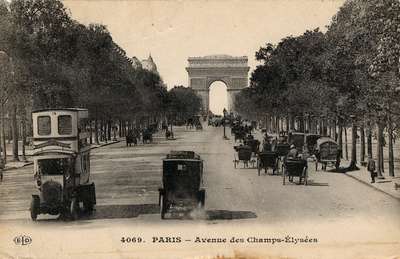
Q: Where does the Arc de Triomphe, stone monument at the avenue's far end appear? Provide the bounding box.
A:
[186,55,250,112]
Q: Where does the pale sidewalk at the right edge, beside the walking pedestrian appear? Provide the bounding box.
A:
[342,162,400,200]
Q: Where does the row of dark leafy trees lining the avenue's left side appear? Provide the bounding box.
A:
[0,0,202,160]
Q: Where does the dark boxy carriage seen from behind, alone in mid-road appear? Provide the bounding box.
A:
[158,151,205,219]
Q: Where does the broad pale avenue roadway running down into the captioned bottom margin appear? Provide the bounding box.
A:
[0,127,400,258]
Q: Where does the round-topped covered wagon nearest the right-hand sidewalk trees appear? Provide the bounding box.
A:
[315,137,340,170]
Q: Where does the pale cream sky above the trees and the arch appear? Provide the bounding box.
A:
[63,0,344,114]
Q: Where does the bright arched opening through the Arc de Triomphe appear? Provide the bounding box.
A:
[209,81,228,115]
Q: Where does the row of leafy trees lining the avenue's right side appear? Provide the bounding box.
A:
[235,0,400,176]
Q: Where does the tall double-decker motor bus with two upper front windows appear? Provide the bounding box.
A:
[30,108,96,220]
